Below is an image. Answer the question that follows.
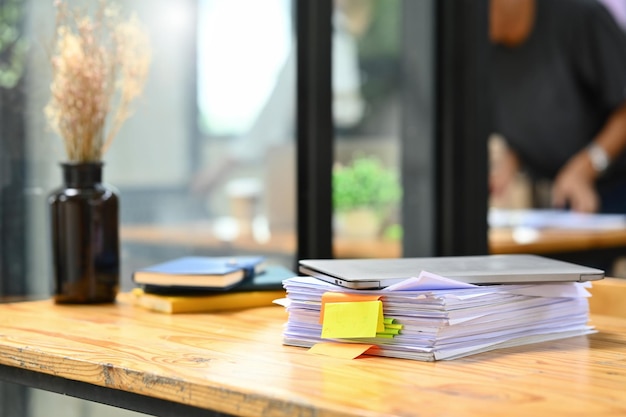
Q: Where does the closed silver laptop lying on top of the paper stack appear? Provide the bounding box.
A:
[299,254,604,289]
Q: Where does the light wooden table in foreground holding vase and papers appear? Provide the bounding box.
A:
[0,280,626,417]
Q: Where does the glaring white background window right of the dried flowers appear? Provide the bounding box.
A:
[198,0,292,136]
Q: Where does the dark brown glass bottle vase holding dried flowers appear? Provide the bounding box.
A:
[48,162,120,304]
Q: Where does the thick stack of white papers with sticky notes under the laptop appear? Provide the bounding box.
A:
[283,272,594,361]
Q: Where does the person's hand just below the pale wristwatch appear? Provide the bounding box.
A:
[552,153,600,213]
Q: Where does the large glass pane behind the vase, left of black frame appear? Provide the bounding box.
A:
[0,0,296,296]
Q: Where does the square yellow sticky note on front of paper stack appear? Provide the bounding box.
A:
[322,300,385,339]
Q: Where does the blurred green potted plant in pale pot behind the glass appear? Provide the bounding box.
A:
[332,156,402,237]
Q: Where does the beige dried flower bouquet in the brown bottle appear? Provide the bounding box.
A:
[45,0,151,162]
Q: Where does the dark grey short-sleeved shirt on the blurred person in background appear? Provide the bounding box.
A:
[492,0,626,182]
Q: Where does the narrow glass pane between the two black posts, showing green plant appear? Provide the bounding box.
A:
[332,0,402,258]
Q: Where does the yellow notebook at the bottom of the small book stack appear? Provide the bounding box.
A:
[128,288,285,314]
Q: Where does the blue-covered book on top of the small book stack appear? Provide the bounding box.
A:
[133,256,265,289]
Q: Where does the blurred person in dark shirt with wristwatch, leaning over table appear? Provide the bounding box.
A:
[489,0,626,213]
